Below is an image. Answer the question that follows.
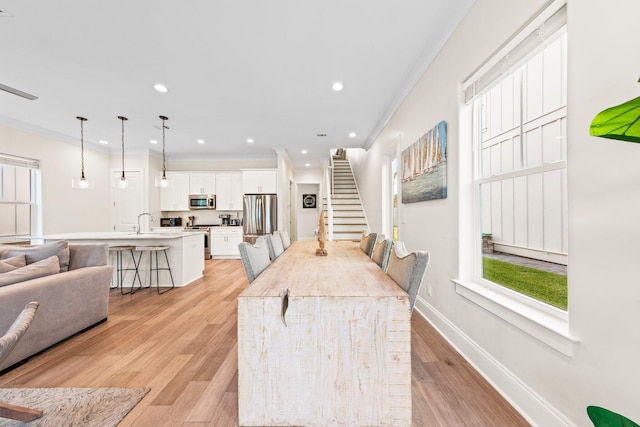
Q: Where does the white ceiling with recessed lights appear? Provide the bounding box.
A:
[0,0,474,169]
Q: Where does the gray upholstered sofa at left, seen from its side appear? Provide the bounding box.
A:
[0,242,113,372]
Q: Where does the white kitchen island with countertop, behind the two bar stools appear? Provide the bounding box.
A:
[42,230,204,289]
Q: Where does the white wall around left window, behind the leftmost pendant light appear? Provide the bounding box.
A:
[0,126,111,234]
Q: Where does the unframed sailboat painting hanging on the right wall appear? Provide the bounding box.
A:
[401,120,447,203]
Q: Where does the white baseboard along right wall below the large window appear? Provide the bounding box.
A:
[415,296,576,427]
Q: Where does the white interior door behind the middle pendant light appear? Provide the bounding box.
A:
[111,171,148,232]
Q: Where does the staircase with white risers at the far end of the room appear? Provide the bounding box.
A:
[323,159,369,241]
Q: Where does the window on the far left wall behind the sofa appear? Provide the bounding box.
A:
[0,154,39,243]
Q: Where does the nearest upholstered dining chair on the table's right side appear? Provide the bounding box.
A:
[387,242,430,311]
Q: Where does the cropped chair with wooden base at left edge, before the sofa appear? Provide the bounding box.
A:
[0,301,42,422]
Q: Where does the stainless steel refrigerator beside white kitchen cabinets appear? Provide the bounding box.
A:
[242,194,278,244]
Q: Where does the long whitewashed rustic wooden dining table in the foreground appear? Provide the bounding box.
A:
[238,241,411,427]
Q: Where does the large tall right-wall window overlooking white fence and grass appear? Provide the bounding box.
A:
[465,3,568,310]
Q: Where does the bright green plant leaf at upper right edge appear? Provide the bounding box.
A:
[589,97,640,142]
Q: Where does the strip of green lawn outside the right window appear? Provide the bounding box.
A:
[482,257,567,310]
